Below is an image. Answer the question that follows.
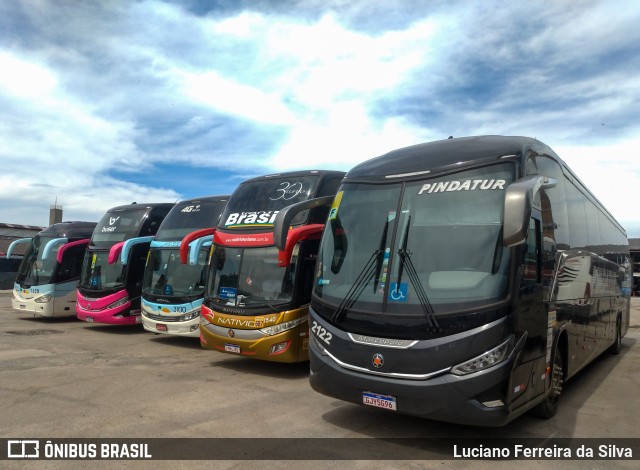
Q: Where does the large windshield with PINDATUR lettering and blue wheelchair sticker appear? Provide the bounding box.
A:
[314,164,514,320]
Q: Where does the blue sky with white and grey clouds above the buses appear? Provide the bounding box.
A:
[0,0,640,237]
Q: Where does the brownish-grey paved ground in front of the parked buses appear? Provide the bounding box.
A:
[0,291,640,469]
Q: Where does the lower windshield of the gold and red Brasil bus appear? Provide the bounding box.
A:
[205,246,295,308]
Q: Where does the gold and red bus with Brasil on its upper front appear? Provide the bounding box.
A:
[182,170,344,362]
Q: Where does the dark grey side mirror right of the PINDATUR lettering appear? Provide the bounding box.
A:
[503,175,556,247]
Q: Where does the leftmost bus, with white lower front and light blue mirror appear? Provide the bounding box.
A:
[7,222,96,317]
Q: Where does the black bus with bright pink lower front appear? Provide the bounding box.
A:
[76,203,174,325]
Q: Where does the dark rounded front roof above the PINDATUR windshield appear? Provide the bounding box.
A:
[346,135,561,181]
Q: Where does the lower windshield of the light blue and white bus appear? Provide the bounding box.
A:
[142,248,209,297]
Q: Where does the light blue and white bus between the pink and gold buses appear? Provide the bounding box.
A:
[142,195,229,338]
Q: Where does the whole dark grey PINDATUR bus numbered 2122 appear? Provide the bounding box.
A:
[274,136,631,426]
